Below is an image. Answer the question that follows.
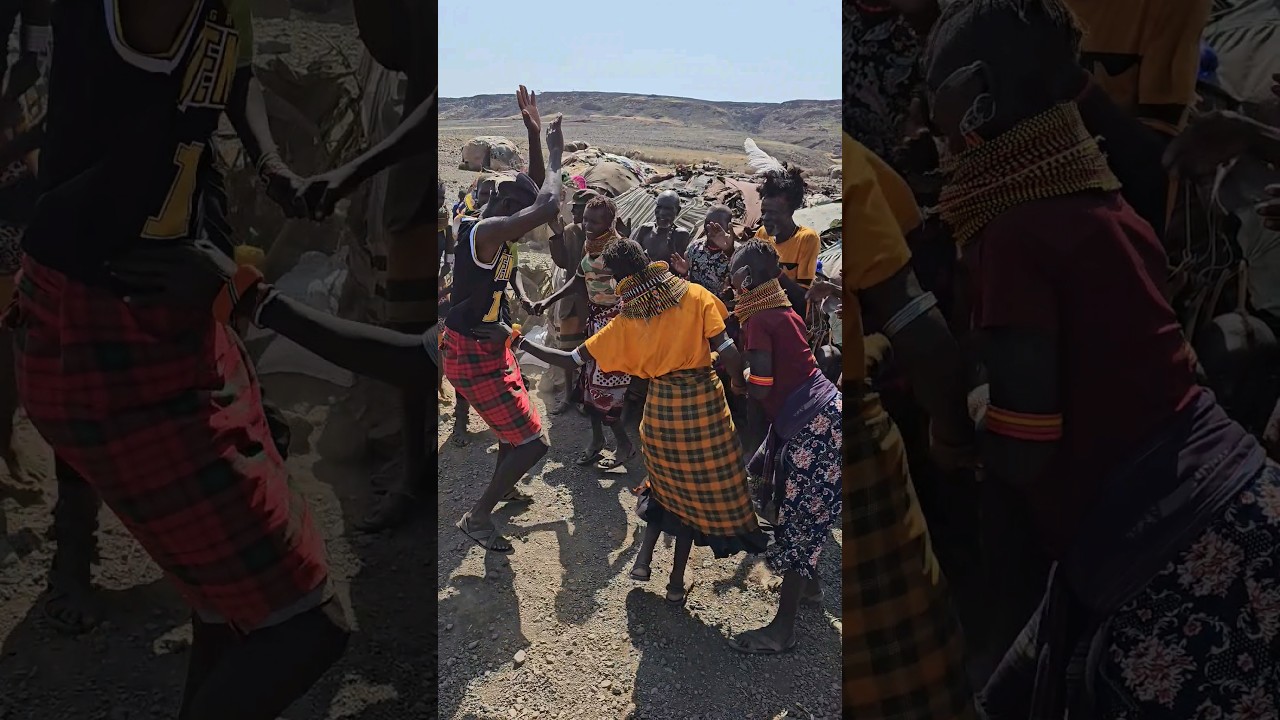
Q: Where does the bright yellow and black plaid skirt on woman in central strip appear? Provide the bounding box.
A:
[640,368,768,557]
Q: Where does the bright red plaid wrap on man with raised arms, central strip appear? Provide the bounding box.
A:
[440,328,543,445]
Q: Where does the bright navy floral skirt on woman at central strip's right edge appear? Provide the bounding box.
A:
[765,395,844,579]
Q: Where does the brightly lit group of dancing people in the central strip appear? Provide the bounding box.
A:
[428,87,842,655]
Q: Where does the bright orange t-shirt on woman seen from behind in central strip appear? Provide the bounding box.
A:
[582,283,728,379]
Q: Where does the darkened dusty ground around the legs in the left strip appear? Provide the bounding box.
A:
[0,375,436,720]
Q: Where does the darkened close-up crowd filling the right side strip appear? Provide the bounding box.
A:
[842,0,1280,720]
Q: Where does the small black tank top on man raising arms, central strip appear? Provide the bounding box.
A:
[444,220,516,336]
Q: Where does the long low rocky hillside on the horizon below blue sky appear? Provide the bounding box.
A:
[439,92,840,149]
